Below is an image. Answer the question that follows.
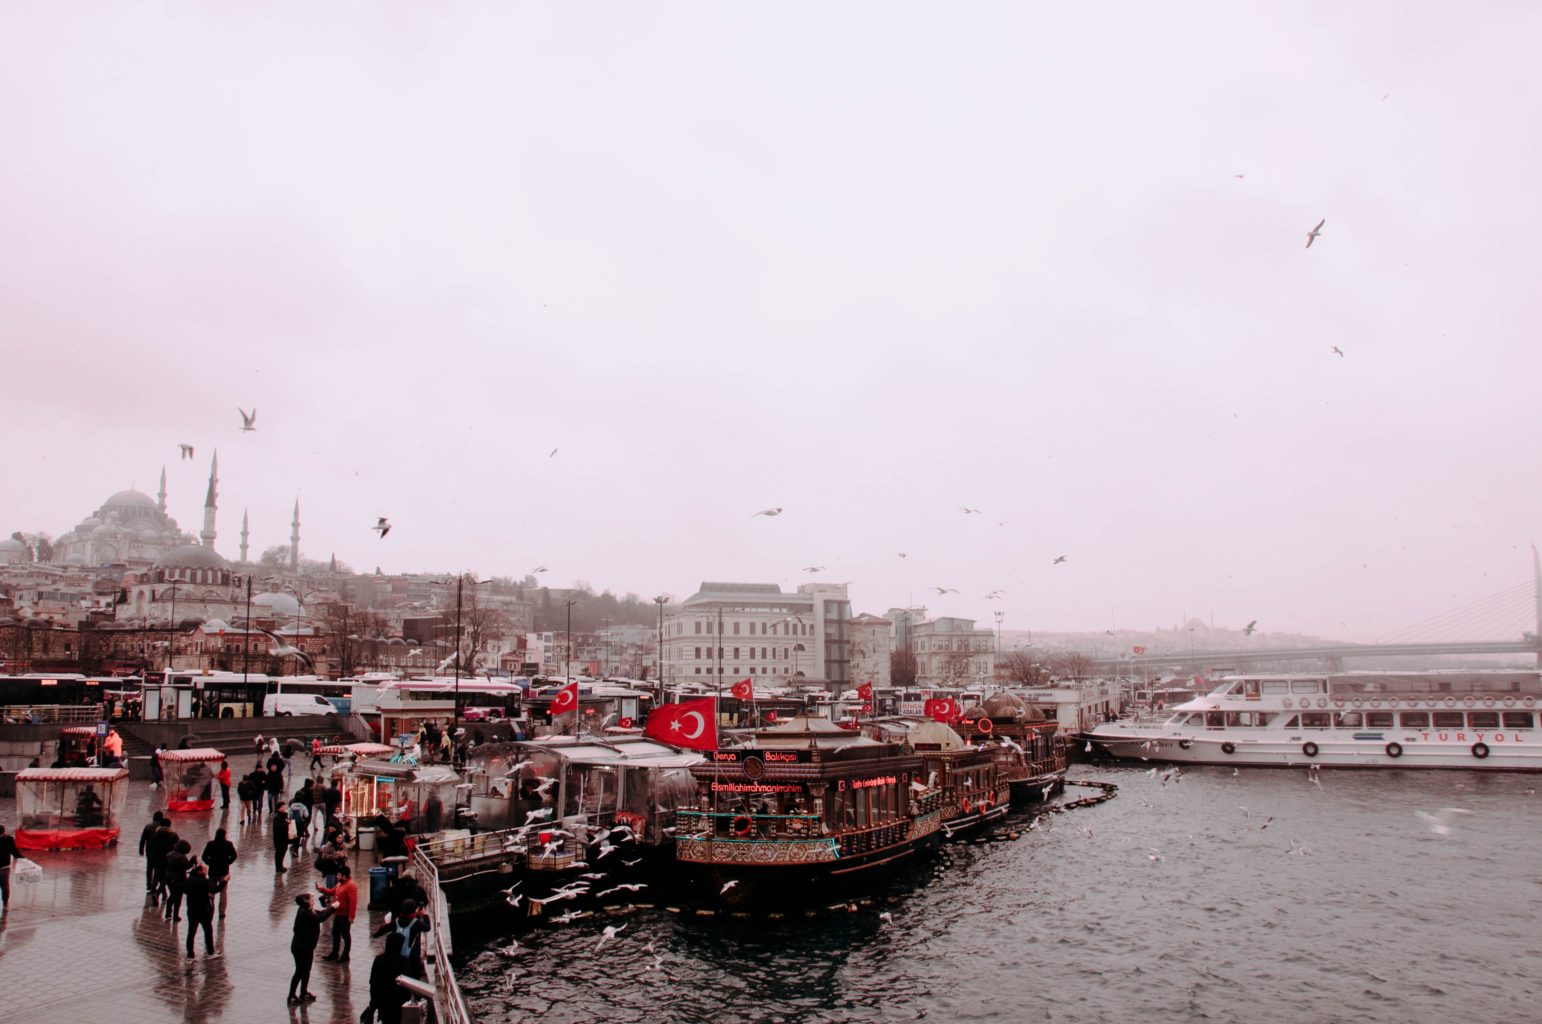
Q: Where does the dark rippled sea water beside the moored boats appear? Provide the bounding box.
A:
[458,765,1542,1024]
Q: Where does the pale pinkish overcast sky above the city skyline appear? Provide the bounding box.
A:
[0,0,1542,638]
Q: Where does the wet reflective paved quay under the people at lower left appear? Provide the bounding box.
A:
[0,779,381,1024]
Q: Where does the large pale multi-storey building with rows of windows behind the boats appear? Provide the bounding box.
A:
[663,583,851,688]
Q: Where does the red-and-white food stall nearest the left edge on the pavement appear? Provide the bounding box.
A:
[15,768,128,850]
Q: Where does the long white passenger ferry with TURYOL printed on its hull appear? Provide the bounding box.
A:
[1082,671,1542,771]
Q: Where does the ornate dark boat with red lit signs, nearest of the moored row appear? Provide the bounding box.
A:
[675,716,942,908]
